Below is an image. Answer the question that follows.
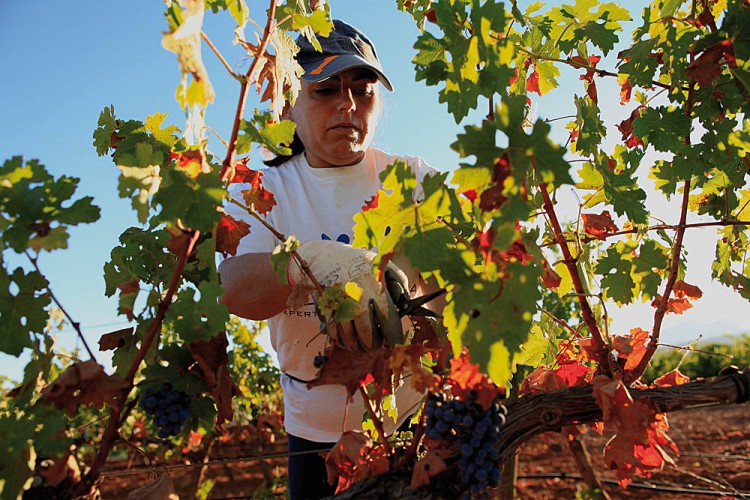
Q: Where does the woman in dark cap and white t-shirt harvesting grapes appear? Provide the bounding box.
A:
[219,20,434,499]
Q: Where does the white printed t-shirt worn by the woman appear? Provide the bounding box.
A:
[226,148,436,442]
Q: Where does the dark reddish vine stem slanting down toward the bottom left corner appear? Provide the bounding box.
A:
[81,231,201,487]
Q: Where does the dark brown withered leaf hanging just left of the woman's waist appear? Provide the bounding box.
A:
[188,332,242,425]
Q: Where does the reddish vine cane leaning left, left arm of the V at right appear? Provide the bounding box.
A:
[539,183,612,374]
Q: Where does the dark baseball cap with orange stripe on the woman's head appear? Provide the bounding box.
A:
[297,19,393,92]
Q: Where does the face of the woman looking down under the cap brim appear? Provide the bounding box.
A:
[289,69,380,168]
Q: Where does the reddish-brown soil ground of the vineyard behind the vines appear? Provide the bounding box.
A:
[100,403,750,500]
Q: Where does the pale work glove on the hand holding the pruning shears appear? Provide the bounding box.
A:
[288,240,409,351]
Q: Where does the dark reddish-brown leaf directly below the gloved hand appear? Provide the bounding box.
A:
[307,343,393,399]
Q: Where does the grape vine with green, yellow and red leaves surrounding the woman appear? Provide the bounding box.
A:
[0,0,750,497]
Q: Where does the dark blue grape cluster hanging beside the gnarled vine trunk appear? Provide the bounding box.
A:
[425,393,506,496]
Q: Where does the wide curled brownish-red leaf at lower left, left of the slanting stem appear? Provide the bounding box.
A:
[41,360,130,417]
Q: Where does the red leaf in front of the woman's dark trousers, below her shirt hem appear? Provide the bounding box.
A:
[326,431,390,493]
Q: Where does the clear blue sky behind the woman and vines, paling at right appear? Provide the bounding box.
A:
[0,0,750,376]
